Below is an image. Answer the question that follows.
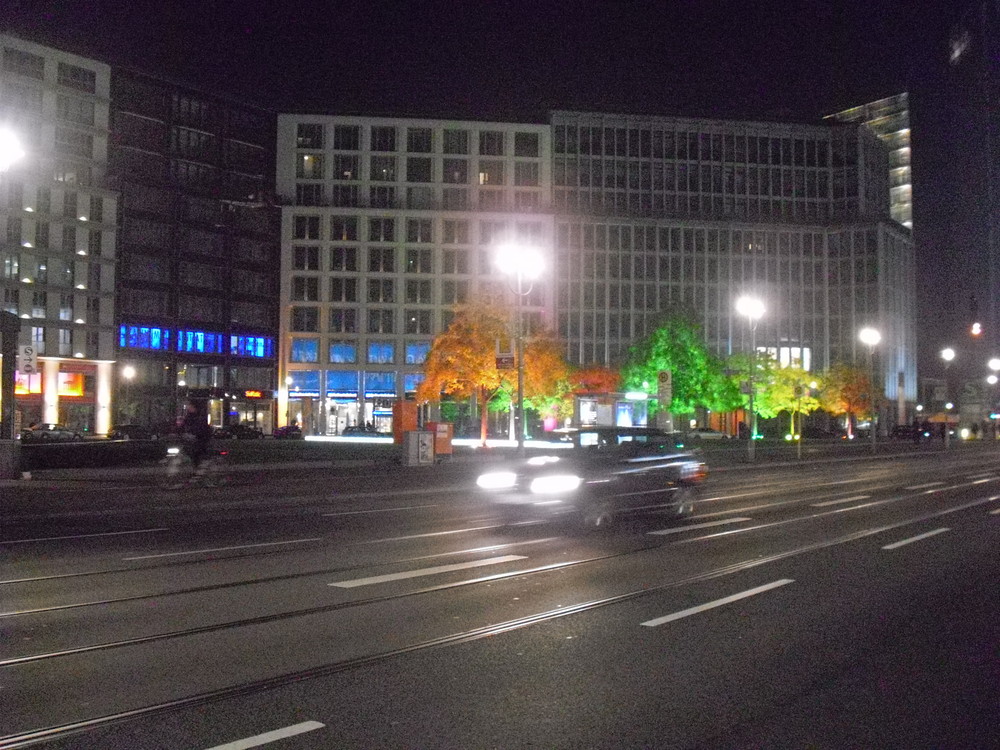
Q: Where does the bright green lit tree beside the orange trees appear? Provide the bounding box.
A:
[622,310,740,414]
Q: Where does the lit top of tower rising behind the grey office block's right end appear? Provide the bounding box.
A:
[826,91,913,229]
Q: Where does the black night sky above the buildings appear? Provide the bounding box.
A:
[0,0,980,368]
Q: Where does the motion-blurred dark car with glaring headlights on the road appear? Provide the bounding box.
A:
[476,427,706,527]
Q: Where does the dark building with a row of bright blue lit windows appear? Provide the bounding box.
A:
[111,68,279,431]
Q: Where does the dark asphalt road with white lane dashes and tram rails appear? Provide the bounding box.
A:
[0,443,1000,750]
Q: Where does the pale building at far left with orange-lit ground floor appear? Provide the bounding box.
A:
[0,35,118,434]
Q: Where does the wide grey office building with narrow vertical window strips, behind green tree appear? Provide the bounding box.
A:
[552,112,917,420]
